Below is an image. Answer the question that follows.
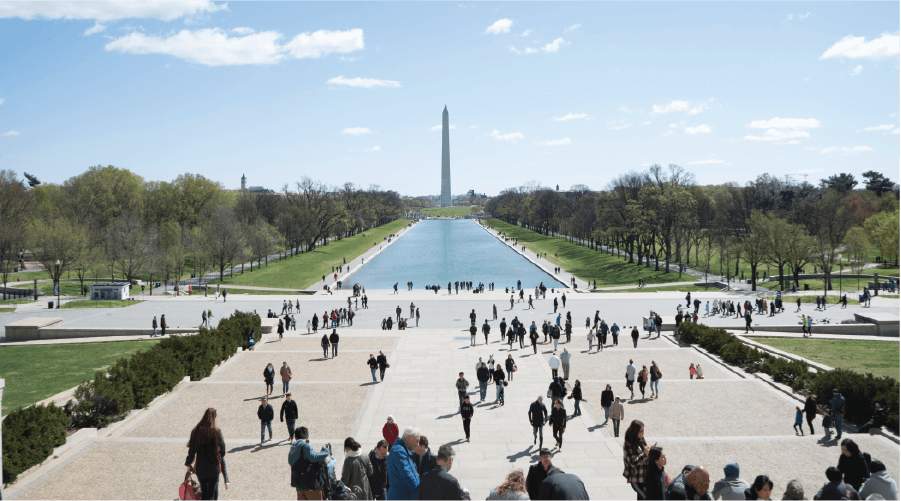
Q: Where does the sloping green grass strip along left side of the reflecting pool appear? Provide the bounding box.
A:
[211,219,410,294]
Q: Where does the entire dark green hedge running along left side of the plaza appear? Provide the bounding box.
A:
[3,311,262,483]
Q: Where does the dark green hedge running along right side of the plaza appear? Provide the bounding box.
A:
[676,323,901,432]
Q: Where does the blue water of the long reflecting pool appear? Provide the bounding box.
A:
[345,219,563,290]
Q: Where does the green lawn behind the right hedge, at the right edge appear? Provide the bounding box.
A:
[754,338,901,380]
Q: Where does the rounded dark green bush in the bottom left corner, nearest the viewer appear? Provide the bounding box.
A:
[3,403,69,483]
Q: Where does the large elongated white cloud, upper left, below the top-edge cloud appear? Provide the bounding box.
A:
[106,28,363,66]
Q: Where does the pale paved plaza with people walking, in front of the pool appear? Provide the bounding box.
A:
[4,290,899,501]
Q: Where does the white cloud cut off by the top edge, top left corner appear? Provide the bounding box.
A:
[0,0,228,22]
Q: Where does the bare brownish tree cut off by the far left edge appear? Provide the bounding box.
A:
[0,170,34,299]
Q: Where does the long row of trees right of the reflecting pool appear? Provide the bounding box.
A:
[487,165,899,290]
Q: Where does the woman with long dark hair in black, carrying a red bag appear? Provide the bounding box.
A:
[185,407,227,501]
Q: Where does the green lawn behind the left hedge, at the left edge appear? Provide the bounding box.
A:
[0,339,157,416]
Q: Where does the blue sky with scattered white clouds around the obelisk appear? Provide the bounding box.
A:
[0,0,901,196]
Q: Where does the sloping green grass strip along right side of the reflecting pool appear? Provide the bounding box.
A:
[483,219,684,288]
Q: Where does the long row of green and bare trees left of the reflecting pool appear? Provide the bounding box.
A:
[0,166,404,296]
